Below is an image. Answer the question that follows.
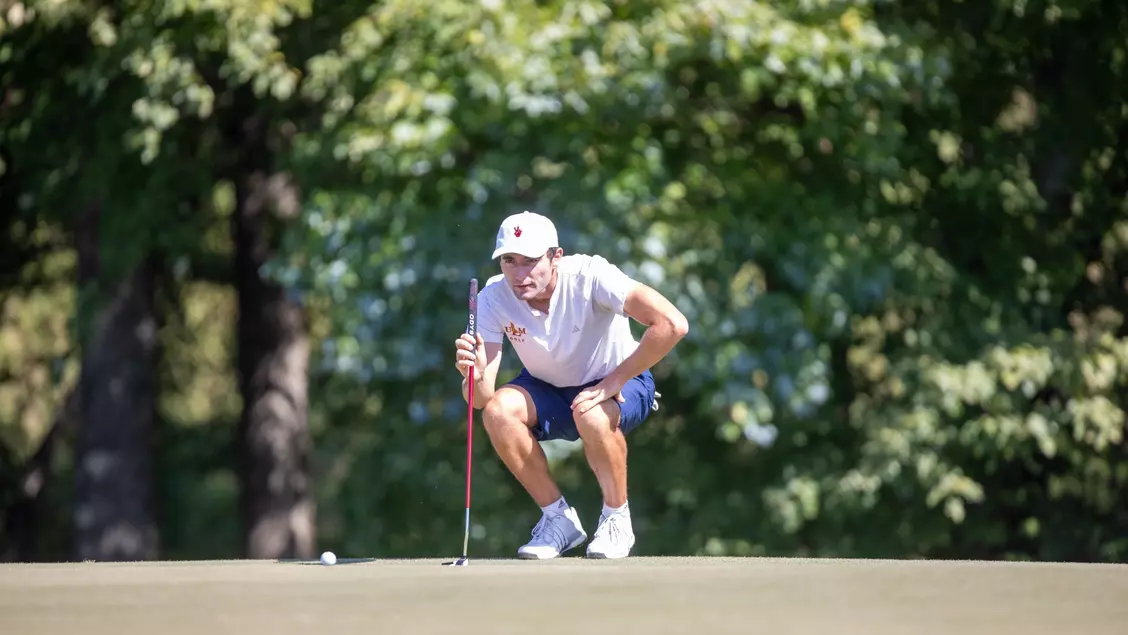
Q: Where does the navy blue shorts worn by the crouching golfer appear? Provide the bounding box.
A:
[506,369,658,441]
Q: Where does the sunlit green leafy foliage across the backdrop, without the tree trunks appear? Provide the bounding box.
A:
[0,0,1128,559]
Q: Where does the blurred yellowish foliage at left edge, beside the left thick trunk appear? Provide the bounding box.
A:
[0,215,78,562]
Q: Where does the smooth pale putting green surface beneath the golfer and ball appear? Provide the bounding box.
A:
[0,557,1128,635]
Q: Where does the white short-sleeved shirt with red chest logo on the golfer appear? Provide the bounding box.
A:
[477,254,638,387]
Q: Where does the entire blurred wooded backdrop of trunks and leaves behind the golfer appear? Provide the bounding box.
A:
[0,0,1128,562]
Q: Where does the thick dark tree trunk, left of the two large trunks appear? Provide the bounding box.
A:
[73,209,158,561]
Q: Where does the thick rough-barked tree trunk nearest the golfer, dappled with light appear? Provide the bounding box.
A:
[232,109,316,558]
